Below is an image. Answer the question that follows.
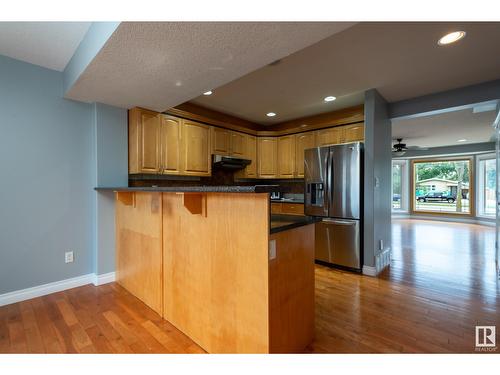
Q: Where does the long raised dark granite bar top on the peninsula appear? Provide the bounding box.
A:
[95,185,281,193]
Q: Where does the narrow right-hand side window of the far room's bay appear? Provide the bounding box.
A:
[478,155,497,217]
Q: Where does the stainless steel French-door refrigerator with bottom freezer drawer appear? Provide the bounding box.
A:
[304,142,363,270]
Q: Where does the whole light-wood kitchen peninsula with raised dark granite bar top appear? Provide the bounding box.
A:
[97,185,314,353]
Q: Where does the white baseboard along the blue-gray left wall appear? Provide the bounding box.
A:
[0,272,115,306]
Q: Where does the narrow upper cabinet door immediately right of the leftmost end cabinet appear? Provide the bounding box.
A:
[160,115,182,174]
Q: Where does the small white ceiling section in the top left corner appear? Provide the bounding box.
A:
[0,22,90,71]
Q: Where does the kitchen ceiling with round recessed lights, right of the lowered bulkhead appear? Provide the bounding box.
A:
[192,22,500,124]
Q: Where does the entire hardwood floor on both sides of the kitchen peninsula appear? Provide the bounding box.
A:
[0,220,500,353]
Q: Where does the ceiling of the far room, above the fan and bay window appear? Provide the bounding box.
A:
[392,109,495,147]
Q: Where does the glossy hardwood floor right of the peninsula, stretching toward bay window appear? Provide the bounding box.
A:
[309,220,500,353]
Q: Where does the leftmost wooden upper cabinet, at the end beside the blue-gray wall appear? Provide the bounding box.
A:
[128,108,161,173]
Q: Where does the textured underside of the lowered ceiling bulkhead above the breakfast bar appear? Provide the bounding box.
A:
[66,22,353,111]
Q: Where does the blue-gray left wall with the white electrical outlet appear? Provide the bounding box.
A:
[0,56,95,294]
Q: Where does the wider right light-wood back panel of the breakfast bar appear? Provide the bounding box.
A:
[163,193,269,353]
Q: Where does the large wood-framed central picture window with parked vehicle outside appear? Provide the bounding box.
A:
[412,158,473,215]
